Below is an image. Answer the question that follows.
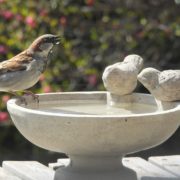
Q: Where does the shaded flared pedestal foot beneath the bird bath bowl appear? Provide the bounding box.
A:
[54,157,137,180]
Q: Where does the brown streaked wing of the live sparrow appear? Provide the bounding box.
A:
[0,52,32,75]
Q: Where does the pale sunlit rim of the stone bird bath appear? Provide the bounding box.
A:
[7,91,180,119]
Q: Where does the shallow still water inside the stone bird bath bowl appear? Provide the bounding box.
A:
[29,100,157,115]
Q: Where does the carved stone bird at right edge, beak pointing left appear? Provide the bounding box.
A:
[137,68,180,102]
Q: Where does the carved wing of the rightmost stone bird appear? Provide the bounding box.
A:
[159,70,180,91]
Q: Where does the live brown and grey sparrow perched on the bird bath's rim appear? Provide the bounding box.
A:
[0,34,60,103]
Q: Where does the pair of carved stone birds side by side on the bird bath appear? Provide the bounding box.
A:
[102,55,180,101]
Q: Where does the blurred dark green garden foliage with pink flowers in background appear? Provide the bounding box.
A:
[0,0,180,163]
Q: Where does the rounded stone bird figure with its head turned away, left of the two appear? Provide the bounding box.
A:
[102,54,143,96]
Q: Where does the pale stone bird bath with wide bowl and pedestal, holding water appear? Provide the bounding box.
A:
[8,92,180,180]
